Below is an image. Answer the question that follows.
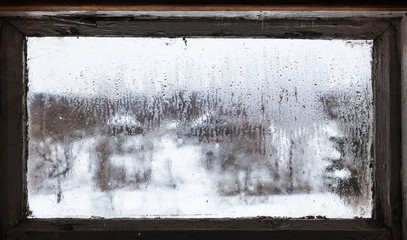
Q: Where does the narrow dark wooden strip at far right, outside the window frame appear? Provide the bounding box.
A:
[399,15,407,240]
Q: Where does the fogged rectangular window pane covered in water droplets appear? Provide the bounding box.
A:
[27,37,373,218]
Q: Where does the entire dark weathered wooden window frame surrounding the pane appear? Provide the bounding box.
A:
[0,13,402,239]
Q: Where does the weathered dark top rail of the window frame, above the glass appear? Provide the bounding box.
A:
[8,17,389,39]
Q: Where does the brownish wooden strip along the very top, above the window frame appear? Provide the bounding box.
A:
[0,0,407,11]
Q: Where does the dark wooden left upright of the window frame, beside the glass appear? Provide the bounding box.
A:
[0,23,25,240]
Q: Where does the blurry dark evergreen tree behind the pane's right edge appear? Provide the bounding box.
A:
[321,89,372,203]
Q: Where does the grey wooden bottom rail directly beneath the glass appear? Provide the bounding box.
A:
[5,218,388,232]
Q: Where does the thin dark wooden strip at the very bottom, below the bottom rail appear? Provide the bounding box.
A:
[5,231,389,240]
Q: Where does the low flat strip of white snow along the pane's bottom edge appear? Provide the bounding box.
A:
[30,187,371,218]
